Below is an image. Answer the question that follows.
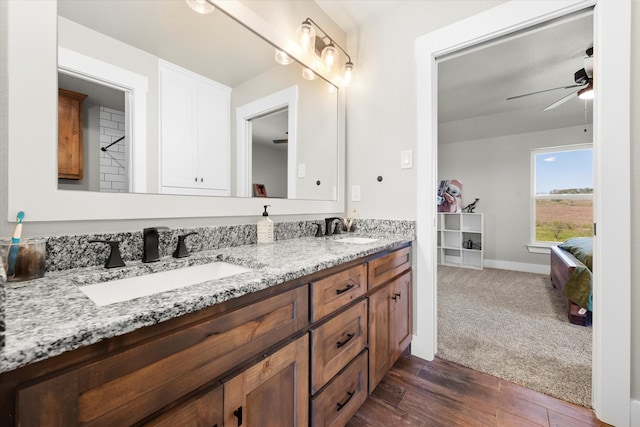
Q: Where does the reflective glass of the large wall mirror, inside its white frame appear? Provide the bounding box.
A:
[58,0,338,200]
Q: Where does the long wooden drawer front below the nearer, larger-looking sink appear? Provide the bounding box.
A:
[17,286,309,426]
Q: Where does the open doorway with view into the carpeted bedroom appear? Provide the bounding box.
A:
[436,9,593,407]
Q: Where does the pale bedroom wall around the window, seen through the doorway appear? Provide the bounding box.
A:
[438,126,593,267]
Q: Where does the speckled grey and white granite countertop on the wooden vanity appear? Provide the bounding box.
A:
[0,234,413,373]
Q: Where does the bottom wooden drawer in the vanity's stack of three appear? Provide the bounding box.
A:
[311,350,367,427]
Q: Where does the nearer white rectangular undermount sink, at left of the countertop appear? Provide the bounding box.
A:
[80,262,251,306]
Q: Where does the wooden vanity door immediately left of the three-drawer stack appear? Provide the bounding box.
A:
[224,335,309,427]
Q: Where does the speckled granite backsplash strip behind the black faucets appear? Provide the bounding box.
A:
[43,218,415,272]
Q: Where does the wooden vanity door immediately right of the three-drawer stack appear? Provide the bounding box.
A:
[369,283,393,392]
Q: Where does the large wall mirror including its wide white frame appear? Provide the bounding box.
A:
[4,0,345,224]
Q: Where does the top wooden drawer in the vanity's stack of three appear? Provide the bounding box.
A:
[311,264,367,322]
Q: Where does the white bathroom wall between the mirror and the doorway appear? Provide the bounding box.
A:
[346,1,501,219]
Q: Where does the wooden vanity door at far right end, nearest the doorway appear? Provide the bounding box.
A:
[391,270,413,365]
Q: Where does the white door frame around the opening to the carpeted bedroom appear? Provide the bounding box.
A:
[412,0,631,426]
